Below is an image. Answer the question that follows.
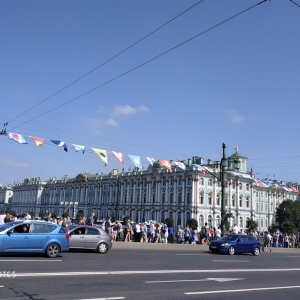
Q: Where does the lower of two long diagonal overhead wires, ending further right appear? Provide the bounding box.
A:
[7,0,268,129]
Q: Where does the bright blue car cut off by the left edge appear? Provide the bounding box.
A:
[0,221,69,258]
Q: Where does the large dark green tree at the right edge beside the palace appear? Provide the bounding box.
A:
[276,200,300,233]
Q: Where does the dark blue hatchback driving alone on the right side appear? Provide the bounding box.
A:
[209,234,260,256]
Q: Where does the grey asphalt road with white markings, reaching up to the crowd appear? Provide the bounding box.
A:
[0,243,300,300]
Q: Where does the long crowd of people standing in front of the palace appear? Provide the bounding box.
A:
[0,211,300,251]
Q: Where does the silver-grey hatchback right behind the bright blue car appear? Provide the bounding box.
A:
[67,225,112,254]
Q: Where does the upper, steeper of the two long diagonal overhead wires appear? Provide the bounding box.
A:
[8,0,205,122]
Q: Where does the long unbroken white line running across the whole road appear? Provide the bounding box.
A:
[15,268,300,277]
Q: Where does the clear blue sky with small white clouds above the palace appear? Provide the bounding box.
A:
[0,0,300,185]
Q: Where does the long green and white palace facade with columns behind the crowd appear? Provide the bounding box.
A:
[0,149,299,231]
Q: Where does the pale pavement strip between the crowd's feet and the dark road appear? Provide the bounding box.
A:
[112,242,300,254]
